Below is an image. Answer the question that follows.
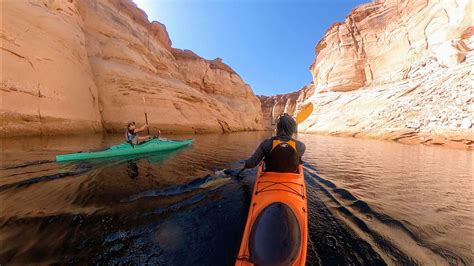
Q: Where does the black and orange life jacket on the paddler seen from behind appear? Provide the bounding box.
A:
[264,138,300,173]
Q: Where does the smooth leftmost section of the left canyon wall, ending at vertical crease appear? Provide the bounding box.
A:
[0,1,102,135]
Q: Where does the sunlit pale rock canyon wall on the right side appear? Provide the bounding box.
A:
[263,0,474,148]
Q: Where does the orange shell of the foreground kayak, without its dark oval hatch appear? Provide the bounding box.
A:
[235,165,308,266]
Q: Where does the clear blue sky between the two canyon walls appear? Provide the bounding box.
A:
[134,0,370,95]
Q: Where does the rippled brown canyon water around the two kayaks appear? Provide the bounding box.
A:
[0,132,474,265]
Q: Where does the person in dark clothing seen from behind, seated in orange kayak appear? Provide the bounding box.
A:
[244,113,306,173]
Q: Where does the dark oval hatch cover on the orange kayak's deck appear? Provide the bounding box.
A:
[249,202,301,265]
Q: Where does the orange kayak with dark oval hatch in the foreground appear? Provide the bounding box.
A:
[235,165,308,266]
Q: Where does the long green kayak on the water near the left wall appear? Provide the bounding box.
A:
[56,139,193,162]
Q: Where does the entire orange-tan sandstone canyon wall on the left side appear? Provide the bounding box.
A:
[0,0,262,136]
